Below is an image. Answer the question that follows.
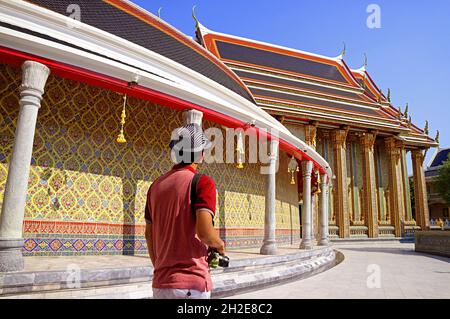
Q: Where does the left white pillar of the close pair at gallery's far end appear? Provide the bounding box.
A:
[300,161,313,249]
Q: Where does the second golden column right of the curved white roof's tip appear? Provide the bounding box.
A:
[360,132,378,237]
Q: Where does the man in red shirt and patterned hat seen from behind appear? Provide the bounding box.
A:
[145,123,224,299]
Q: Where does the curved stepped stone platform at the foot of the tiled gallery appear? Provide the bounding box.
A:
[0,246,336,299]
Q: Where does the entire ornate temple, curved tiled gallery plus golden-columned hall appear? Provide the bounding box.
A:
[0,0,437,272]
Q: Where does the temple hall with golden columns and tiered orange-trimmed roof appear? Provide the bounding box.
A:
[196,23,437,238]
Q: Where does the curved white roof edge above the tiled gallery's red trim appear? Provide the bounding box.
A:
[0,0,333,178]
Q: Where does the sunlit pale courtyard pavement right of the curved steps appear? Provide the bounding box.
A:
[230,242,450,299]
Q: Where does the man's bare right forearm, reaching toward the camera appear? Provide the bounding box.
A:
[196,208,225,254]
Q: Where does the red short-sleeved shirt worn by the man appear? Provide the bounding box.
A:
[145,165,216,291]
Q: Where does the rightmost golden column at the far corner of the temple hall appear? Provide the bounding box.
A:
[411,149,430,230]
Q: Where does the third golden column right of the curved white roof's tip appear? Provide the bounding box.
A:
[385,137,404,237]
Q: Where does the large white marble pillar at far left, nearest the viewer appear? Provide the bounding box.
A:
[0,61,50,272]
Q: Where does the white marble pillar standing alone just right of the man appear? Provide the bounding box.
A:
[260,140,278,255]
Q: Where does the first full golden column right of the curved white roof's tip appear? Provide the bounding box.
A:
[332,128,350,238]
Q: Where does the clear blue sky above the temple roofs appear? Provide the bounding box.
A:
[133,0,450,168]
